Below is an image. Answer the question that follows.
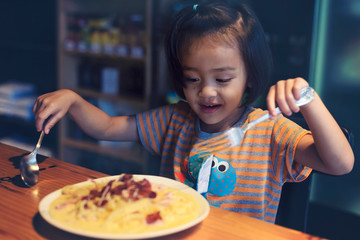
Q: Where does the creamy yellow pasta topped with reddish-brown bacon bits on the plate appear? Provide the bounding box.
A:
[50,174,200,234]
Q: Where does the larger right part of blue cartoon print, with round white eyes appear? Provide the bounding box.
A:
[208,157,236,197]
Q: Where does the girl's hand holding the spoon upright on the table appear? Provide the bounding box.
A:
[33,89,78,134]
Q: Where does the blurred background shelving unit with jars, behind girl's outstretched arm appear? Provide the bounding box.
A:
[57,0,154,171]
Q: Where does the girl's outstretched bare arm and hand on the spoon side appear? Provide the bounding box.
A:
[33,89,138,141]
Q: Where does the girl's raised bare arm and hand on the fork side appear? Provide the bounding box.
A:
[267,78,354,175]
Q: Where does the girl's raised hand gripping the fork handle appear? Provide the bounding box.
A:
[266,77,309,119]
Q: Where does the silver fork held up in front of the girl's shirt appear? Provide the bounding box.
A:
[195,87,314,153]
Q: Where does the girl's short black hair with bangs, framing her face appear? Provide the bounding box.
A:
[165,0,272,105]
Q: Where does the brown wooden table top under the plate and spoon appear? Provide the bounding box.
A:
[0,143,319,240]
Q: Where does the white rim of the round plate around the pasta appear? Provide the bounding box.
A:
[39,174,210,239]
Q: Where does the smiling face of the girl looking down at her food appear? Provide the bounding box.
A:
[181,37,247,132]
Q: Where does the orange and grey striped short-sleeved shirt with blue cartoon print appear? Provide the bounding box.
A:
[136,101,311,223]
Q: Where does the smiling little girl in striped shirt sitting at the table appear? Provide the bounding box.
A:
[33,1,354,222]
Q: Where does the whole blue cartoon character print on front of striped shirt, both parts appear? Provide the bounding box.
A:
[183,153,236,197]
